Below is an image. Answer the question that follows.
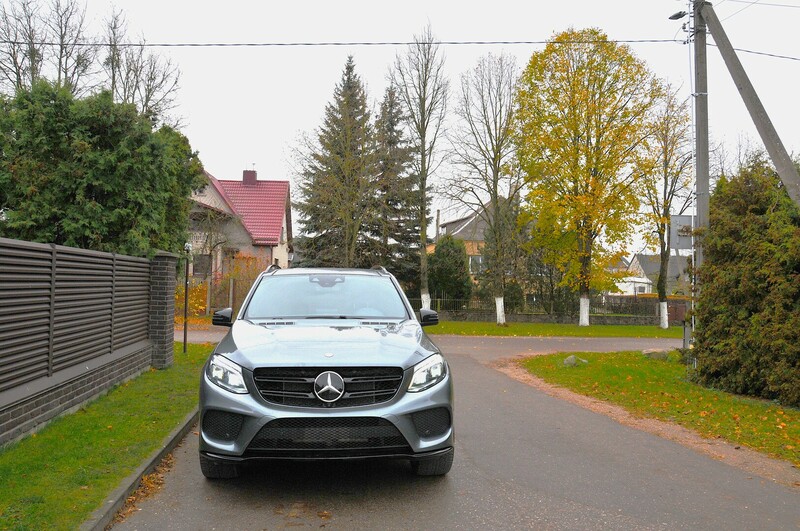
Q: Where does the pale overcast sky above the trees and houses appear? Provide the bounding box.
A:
[87,0,800,222]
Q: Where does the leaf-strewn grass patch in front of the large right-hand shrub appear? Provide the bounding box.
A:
[523,352,800,465]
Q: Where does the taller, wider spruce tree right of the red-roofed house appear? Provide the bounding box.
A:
[297,56,376,267]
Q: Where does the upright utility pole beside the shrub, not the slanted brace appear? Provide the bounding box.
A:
[693,4,709,276]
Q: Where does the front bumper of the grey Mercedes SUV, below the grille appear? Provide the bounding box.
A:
[200,373,454,462]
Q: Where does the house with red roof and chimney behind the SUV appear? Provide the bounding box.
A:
[190,170,292,277]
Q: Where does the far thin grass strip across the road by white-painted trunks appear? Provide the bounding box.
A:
[432,321,683,338]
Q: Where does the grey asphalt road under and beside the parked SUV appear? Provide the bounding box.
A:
[115,336,800,530]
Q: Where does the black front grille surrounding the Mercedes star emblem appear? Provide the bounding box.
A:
[253,367,403,408]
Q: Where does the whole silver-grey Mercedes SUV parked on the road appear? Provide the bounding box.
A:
[200,267,453,478]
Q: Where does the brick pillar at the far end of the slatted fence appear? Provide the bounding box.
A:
[148,251,178,369]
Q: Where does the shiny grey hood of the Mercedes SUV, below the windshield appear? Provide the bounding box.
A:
[215,320,439,370]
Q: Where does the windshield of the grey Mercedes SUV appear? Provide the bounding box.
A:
[244,272,408,320]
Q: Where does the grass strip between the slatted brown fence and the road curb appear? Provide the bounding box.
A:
[0,344,212,529]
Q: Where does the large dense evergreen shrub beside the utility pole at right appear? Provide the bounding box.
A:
[696,156,800,406]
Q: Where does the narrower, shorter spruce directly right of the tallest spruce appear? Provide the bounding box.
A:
[367,87,419,287]
